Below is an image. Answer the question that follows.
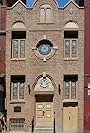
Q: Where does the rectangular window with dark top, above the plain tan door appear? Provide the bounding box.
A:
[64,75,78,99]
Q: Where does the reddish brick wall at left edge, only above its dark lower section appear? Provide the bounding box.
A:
[0,6,6,74]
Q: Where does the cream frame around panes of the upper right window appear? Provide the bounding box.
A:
[64,38,78,60]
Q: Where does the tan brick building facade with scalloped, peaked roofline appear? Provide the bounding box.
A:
[6,0,84,133]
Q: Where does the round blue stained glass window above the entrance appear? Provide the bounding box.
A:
[38,43,51,55]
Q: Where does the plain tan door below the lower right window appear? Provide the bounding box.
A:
[63,106,78,132]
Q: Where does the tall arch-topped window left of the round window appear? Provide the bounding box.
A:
[11,22,26,59]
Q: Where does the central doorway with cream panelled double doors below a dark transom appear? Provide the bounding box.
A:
[36,95,54,127]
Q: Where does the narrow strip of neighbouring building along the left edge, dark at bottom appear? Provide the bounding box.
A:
[0,1,6,115]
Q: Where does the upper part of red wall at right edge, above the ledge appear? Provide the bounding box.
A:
[85,0,90,74]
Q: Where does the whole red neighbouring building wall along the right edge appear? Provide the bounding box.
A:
[84,0,90,131]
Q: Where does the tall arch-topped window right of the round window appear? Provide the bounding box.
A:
[64,21,78,59]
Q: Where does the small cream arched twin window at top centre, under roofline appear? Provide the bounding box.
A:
[40,4,52,23]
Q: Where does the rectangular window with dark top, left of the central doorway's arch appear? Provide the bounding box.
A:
[11,76,25,100]
